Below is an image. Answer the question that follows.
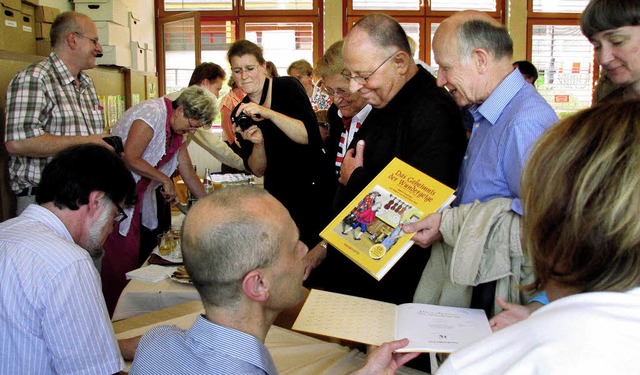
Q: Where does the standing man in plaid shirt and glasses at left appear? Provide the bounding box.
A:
[5,12,111,214]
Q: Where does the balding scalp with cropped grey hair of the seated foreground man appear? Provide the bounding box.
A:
[182,187,295,306]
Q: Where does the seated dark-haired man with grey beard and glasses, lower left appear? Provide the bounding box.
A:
[0,144,137,374]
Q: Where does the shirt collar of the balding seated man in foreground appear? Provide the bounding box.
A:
[187,315,278,375]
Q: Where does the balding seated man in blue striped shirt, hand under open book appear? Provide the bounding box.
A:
[130,187,417,375]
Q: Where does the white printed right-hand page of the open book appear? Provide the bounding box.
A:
[395,303,491,353]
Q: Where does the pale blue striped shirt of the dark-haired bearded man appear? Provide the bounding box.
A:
[0,205,124,374]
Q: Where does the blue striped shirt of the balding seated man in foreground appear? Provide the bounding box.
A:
[129,316,278,375]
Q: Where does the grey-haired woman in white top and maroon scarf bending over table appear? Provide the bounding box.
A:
[101,86,218,314]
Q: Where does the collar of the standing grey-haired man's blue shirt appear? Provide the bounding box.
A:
[469,69,529,125]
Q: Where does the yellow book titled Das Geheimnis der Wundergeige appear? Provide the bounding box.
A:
[320,158,455,280]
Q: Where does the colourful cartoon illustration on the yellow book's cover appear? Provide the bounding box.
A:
[334,185,423,260]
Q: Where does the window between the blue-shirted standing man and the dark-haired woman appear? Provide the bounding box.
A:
[527,0,598,118]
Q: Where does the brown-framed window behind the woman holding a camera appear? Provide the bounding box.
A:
[158,0,323,128]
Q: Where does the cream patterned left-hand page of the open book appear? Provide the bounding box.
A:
[293,289,396,345]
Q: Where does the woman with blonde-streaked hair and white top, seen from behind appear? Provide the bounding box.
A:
[438,101,640,374]
